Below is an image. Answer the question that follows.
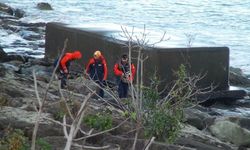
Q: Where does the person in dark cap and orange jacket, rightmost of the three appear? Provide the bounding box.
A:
[114,54,136,98]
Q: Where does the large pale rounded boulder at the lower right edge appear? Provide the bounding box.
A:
[209,118,250,146]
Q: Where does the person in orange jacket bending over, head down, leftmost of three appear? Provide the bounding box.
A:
[56,50,82,89]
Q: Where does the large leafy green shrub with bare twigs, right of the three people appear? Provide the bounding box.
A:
[143,65,192,143]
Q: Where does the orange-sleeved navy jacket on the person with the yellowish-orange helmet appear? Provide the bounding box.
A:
[86,56,108,80]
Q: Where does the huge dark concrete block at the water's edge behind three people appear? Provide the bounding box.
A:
[45,23,229,90]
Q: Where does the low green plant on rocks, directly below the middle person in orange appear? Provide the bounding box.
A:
[83,113,112,131]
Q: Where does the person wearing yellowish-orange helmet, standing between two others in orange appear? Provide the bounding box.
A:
[86,50,108,98]
